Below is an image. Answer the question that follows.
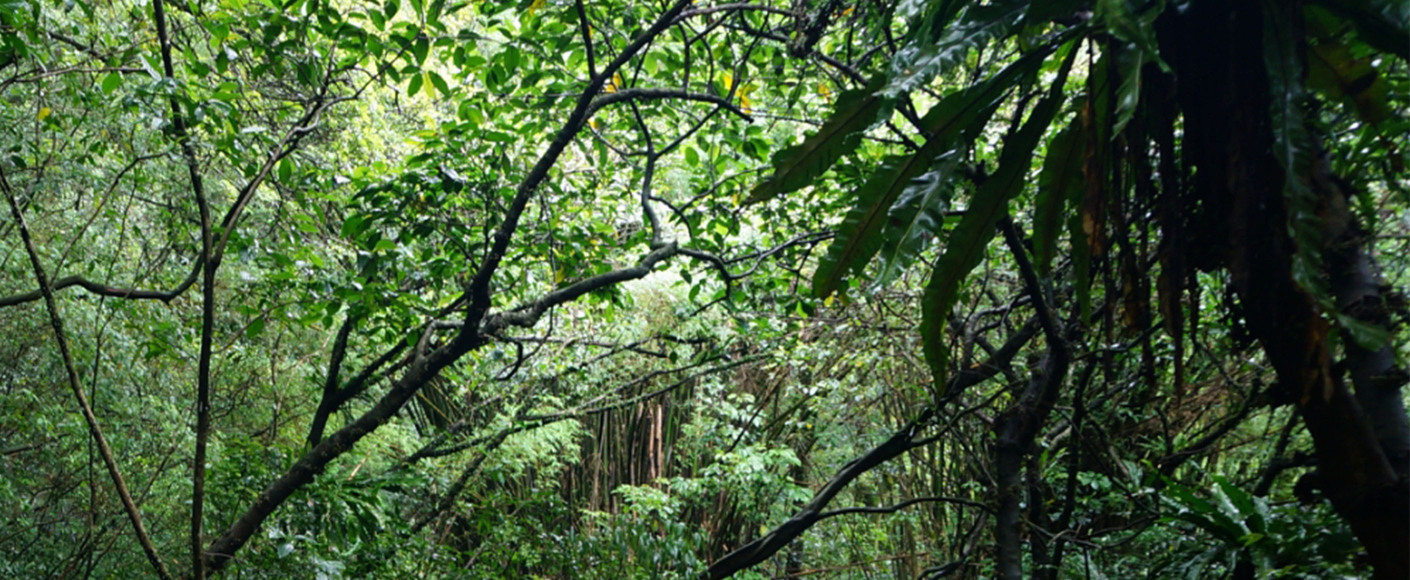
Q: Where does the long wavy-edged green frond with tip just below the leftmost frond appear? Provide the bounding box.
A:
[812,37,1066,298]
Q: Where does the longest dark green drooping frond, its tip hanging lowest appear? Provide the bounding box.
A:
[921,43,1079,385]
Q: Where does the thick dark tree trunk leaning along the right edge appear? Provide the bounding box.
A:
[1159,0,1410,579]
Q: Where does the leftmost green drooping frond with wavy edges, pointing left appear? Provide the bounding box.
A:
[744,78,891,203]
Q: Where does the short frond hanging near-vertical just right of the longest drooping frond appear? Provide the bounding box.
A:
[1034,121,1086,277]
